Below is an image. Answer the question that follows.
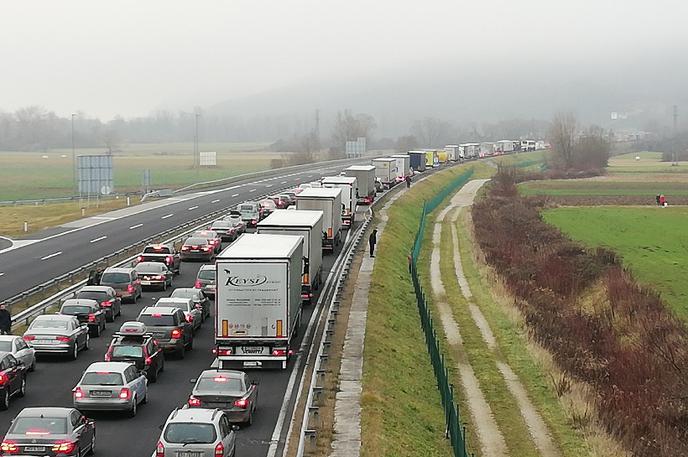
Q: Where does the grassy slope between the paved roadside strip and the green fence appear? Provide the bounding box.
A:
[361,163,492,457]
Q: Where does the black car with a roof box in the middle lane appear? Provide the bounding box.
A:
[105,322,165,382]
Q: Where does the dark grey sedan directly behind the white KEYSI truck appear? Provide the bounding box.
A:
[187,370,258,425]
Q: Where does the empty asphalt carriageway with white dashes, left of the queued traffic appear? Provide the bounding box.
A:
[0,158,370,301]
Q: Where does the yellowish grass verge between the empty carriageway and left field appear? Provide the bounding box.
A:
[0,197,140,237]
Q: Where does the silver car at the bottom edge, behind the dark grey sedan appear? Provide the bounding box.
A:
[155,408,238,457]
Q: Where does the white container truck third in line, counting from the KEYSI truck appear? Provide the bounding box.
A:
[296,187,342,252]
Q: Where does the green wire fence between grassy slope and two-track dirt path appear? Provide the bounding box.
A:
[409,169,473,457]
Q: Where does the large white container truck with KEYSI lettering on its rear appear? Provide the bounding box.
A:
[214,233,303,369]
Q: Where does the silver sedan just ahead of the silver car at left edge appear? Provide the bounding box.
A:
[24,314,89,360]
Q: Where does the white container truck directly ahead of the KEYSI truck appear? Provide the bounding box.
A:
[257,209,323,303]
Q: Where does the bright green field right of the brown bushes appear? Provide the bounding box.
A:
[543,206,688,320]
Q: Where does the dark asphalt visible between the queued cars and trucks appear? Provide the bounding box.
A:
[0,233,344,457]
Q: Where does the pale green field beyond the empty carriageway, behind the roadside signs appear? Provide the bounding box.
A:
[0,143,282,200]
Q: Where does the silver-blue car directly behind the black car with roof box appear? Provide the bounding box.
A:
[72,362,148,417]
